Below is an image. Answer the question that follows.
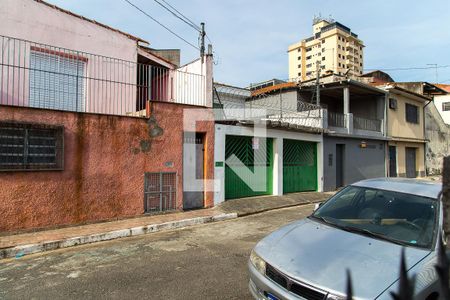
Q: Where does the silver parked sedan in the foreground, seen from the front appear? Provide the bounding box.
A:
[248,178,443,300]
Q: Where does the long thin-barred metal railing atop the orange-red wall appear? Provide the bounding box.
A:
[0,36,207,116]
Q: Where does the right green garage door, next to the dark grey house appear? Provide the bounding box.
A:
[283,140,317,193]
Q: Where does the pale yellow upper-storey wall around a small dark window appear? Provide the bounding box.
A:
[387,90,425,140]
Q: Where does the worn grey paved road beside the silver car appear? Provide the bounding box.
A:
[0,205,312,299]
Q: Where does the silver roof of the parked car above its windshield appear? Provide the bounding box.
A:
[351,178,442,199]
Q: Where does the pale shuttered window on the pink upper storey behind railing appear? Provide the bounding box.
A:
[29,47,87,111]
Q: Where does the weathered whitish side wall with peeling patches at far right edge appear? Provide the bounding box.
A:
[425,102,450,175]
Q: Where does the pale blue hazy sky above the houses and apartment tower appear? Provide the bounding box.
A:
[47,0,450,87]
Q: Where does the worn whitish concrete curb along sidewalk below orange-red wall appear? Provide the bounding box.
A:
[0,213,238,259]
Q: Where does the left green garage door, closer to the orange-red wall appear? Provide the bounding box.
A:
[225,135,273,199]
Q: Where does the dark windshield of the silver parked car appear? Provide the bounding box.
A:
[311,186,438,248]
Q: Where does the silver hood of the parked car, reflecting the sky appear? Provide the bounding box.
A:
[255,219,430,299]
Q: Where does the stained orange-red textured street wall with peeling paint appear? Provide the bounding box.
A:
[0,103,214,231]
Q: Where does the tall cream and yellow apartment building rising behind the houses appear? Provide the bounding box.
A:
[288,18,364,81]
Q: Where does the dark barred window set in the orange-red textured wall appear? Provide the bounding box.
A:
[0,122,64,171]
